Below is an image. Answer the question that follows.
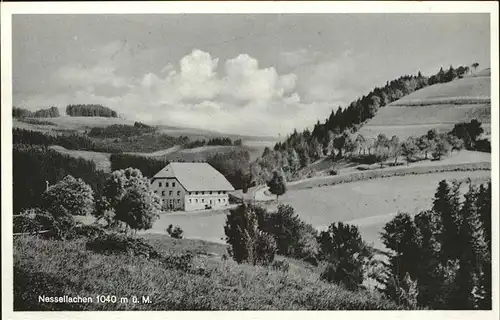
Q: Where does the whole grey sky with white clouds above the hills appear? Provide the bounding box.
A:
[12,13,490,136]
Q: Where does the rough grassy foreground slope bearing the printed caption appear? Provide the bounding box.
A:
[14,236,396,310]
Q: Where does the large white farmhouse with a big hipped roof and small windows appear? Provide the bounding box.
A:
[151,162,234,211]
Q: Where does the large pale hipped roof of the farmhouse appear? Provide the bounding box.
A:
[153,162,234,191]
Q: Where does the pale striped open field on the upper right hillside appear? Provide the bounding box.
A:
[359,69,491,139]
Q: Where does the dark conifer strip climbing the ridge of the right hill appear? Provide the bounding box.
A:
[274,66,470,154]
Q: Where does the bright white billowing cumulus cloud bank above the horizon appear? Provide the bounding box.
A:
[16,47,344,135]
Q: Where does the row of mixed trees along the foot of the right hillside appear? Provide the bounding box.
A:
[250,119,491,184]
